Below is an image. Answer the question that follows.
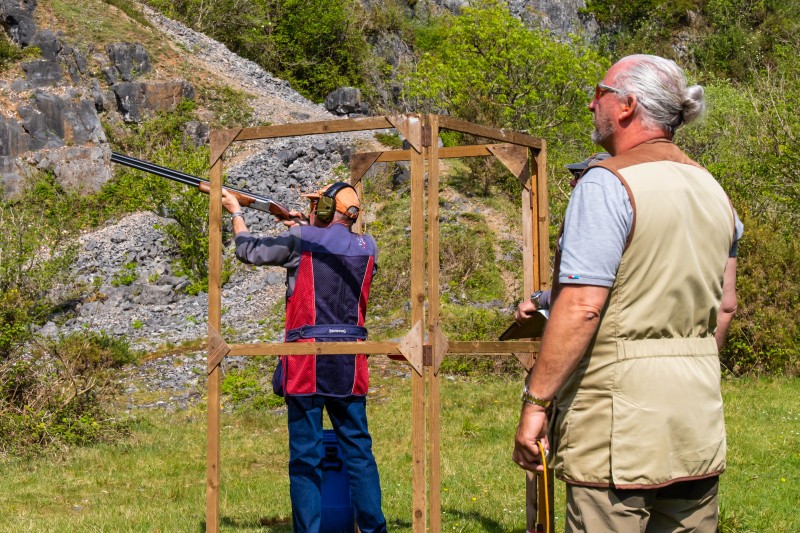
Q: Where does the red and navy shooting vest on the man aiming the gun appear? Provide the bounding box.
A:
[276,224,377,396]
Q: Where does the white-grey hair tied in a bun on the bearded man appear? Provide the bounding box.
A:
[613,54,706,135]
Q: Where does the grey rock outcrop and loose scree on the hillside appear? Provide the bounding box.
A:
[0,0,380,349]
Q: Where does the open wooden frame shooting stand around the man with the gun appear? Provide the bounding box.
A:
[206,114,552,533]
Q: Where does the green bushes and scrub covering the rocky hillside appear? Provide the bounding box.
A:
[0,0,800,456]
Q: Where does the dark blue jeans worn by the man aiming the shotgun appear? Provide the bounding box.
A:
[286,395,386,533]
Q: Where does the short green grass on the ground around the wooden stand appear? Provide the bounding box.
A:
[0,372,800,533]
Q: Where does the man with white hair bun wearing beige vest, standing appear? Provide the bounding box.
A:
[513,55,743,533]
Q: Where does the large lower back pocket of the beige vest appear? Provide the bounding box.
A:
[611,338,725,486]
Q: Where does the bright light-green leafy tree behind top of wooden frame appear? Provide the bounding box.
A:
[404,0,608,192]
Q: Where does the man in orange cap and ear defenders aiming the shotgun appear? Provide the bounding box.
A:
[222,182,386,533]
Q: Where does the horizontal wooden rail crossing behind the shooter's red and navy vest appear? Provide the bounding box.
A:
[230,341,402,357]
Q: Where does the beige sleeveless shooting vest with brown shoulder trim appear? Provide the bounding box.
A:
[551,139,734,488]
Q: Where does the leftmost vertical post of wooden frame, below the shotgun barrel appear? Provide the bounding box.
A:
[206,148,222,533]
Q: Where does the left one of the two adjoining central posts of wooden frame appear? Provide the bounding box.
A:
[406,115,427,533]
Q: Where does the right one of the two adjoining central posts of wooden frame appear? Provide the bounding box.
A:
[424,115,442,533]
